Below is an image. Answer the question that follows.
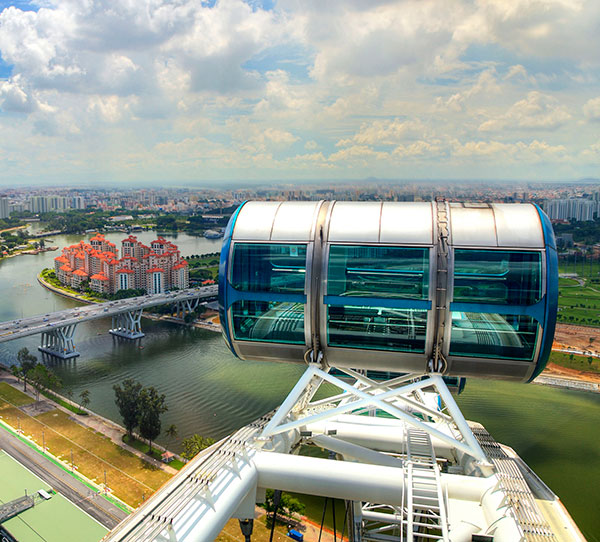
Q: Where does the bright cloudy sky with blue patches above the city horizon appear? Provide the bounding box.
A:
[0,0,600,184]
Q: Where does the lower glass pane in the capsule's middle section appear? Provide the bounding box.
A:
[327,306,427,352]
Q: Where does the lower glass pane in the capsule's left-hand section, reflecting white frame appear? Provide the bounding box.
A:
[231,300,304,344]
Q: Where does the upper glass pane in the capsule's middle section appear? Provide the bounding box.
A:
[327,245,429,299]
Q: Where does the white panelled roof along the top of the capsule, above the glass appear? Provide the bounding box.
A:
[232,201,544,248]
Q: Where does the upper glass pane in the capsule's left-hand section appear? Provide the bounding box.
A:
[231,243,306,293]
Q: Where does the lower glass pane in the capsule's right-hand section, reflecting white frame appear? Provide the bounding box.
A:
[450,312,538,361]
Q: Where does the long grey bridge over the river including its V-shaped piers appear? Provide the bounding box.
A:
[0,286,218,359]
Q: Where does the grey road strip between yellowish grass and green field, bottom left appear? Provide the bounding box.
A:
[0,428,127,529]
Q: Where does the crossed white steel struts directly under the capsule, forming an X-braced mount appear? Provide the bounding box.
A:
[260,364,488,464]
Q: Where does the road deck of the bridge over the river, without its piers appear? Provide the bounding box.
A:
[0,286,218,343]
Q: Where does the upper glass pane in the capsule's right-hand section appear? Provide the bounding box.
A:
[453,249,542,305]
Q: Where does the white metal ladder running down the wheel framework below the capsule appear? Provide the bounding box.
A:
[406,426,448,542]
